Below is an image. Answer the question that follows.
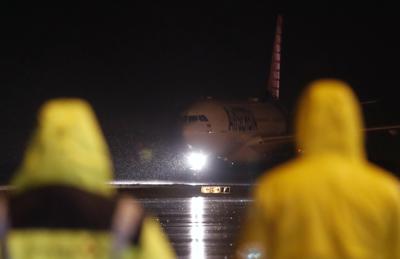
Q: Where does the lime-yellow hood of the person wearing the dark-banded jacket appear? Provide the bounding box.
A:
[12,99,113,196]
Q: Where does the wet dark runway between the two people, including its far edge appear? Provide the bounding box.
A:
[115,184,251,259]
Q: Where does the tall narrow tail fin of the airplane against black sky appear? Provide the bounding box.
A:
[267,15,283,100]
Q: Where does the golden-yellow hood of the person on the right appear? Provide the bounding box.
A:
[296,79,365,159]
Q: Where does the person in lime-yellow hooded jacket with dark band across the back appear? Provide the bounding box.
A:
[0,98,175,259]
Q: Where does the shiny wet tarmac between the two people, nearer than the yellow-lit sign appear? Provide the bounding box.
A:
[140,196,251,259]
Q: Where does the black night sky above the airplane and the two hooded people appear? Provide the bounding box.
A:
[0,4,400,183]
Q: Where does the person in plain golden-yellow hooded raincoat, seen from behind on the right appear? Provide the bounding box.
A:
[237,79,400,259]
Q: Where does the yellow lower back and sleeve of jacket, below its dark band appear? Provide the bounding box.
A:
[6,218,176,259]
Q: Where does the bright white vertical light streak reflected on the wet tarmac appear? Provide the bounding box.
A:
[190,197,206,259]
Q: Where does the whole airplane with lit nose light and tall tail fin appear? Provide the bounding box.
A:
[182,15,400,171]
